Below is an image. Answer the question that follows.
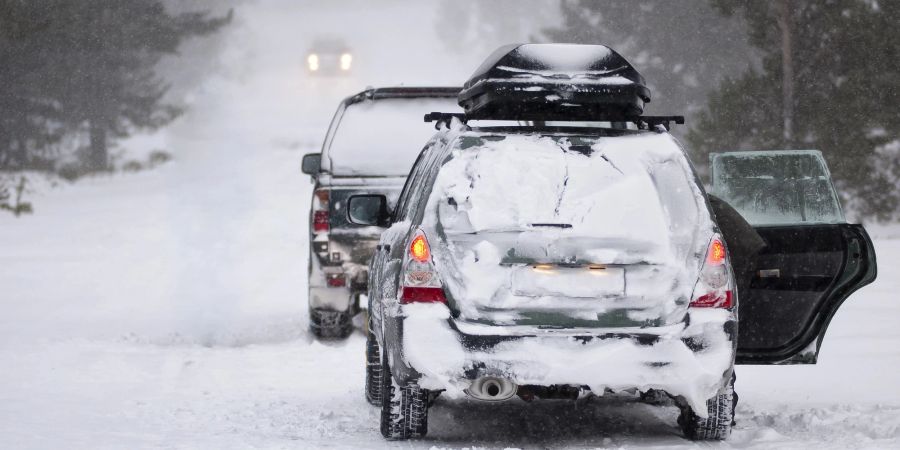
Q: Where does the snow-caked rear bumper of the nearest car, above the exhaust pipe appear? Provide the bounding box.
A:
[386,304,735,410]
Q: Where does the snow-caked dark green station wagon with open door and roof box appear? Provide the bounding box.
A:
[346,46,876,440]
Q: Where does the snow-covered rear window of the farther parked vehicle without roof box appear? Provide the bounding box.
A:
[326,97,462,176]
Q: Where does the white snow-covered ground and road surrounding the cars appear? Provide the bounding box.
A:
[0,2,900,449]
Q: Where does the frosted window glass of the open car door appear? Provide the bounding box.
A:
[710,150,844,225]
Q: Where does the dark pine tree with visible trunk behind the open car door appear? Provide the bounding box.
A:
[688,0,900,219]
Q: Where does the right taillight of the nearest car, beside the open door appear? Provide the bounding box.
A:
[690,234,734,308]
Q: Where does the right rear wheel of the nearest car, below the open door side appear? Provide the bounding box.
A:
[678,379,736,441]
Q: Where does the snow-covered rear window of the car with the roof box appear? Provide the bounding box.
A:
[432,134,708,253]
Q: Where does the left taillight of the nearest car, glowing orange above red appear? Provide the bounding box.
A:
[400,231,447,304]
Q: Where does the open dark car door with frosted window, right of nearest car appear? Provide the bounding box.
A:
[710,150,876,364]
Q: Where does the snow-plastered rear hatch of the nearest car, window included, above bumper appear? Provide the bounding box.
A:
[425,132,711,327]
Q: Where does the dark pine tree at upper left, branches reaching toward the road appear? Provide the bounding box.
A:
[0,0,231,170]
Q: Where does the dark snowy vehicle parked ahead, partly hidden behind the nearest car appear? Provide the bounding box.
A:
[303,87,460,338]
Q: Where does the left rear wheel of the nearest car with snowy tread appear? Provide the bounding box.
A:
[381,361,429,440]
